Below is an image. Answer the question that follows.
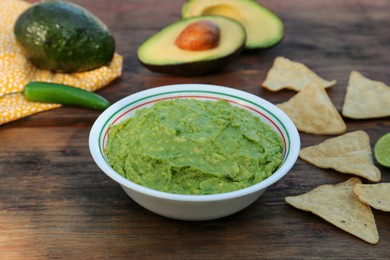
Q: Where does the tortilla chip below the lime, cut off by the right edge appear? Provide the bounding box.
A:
[353,183,390,212]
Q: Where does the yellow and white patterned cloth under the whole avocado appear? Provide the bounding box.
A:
[0,0,123,125]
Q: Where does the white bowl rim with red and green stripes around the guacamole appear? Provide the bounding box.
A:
[89,83,300,203]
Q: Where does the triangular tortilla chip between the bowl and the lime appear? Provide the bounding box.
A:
[299,130,381,182]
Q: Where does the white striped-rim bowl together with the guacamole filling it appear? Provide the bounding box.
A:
[89,84,300,220]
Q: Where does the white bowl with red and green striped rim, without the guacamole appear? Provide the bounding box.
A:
[89,84,300,220]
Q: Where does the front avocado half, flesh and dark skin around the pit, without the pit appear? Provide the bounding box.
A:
[137,16,246,76]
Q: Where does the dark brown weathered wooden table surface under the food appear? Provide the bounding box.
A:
[0,0,390,259]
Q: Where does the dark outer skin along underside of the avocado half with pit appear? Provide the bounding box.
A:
[138,41,245,77]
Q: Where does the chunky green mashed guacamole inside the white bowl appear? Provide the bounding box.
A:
[105,99,283,194]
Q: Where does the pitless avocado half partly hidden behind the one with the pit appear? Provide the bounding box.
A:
[182,0,284,49]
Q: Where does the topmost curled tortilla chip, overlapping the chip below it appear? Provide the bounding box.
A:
[262,57,336,91]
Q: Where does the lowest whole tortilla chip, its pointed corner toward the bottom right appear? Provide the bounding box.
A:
[285,177,379,244]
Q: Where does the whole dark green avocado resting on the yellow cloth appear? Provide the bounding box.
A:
[14,1,115,73]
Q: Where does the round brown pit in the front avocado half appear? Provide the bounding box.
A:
[175,20,221,51]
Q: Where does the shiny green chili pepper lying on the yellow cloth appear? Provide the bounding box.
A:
[23,82,110,110]
